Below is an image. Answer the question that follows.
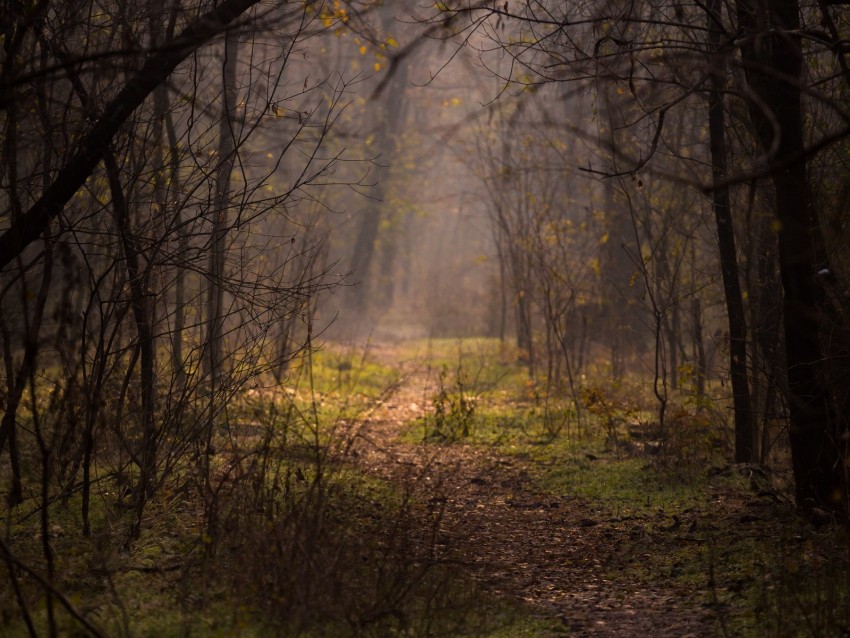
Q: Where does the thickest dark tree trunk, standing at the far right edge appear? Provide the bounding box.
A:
[737,0,848,518]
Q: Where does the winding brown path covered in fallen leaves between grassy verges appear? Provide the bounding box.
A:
[342,346,721,638]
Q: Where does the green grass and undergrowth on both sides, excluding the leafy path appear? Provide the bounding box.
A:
[8,339,850,638]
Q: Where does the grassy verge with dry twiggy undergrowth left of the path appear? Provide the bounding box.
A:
[0,348,549,638]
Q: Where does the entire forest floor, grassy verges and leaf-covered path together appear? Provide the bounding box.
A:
[0,339,850,638]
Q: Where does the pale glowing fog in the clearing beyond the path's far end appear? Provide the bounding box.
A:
[284,3,656,358]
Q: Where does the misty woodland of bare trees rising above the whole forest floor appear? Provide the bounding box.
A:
[0,0,850,636]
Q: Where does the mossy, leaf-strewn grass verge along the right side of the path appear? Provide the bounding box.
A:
[396,343,850,638]
